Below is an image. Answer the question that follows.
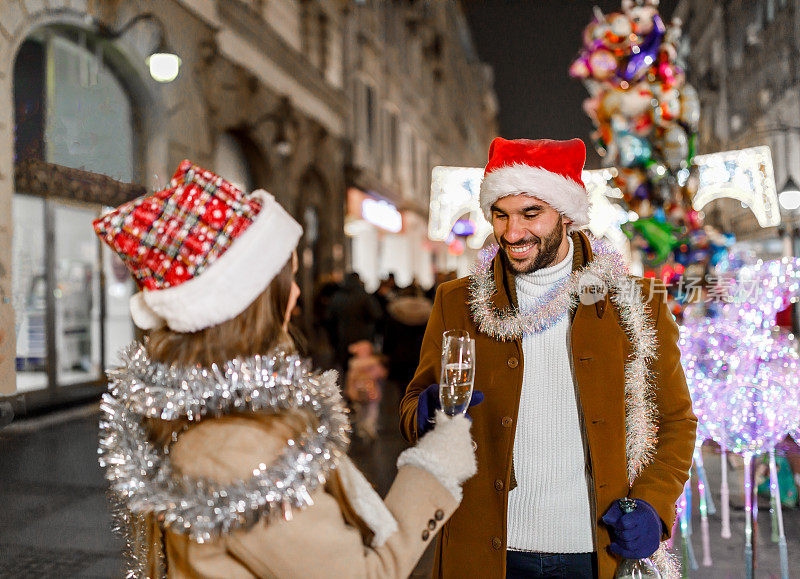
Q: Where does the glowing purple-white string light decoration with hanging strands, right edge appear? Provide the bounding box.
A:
[679,258,800,577]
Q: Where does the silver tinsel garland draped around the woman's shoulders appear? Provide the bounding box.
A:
[99,343,350,576]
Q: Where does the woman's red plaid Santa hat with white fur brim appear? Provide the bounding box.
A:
[94,161,303,332]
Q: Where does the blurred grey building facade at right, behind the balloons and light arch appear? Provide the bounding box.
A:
[675,0,800,258]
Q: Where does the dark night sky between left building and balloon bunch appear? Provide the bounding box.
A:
[463,0,678,169]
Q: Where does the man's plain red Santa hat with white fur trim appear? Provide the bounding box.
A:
[480,137,589,230]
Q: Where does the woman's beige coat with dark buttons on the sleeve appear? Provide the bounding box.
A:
[163,416,458,579]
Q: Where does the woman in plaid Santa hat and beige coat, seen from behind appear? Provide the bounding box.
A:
[95,161,482,579]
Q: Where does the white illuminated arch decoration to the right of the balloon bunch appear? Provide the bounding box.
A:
[692,147,781,227]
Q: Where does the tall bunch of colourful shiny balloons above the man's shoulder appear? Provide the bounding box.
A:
[570,0,700,265]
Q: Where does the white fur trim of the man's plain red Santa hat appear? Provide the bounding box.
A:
[481,163,589,230]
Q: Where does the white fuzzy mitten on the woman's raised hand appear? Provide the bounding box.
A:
[397,410,478,501]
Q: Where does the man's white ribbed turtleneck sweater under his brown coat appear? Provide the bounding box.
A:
[508,238,594,553]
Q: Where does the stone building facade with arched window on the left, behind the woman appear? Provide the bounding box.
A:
[0,0,493,411]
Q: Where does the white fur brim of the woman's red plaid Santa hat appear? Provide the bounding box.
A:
[130,189,303,332]
